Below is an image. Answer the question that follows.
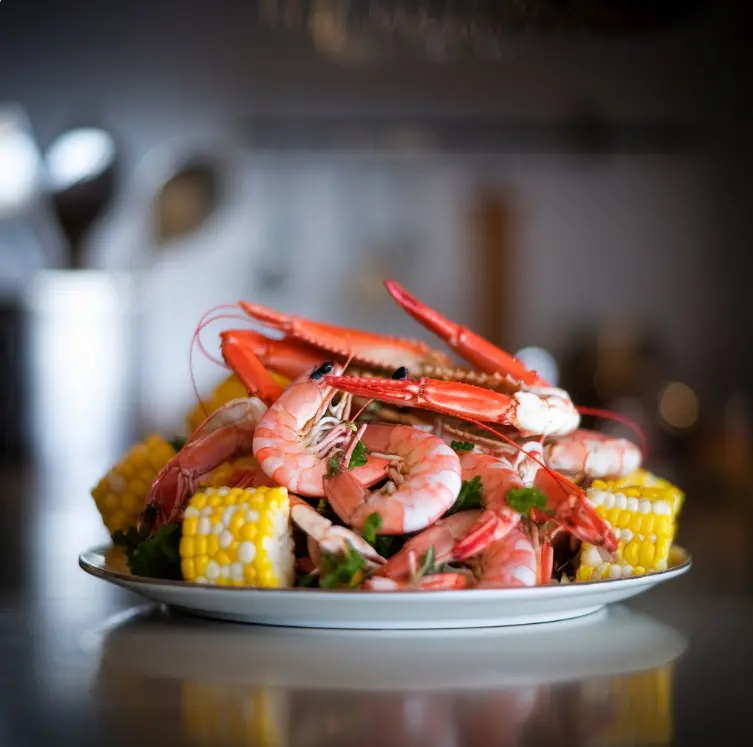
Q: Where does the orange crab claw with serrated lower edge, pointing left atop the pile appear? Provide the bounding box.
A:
[239,301,450,370]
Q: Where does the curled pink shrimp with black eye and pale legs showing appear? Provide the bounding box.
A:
[253,362,388,498]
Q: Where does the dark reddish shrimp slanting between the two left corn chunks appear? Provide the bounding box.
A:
[140,397,267,531]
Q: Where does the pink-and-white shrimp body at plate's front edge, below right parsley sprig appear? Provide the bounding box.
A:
[476,529,539,589]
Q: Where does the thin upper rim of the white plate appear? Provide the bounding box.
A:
[78,543,693,601]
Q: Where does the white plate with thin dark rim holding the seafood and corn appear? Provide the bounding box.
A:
[79,546,691,630]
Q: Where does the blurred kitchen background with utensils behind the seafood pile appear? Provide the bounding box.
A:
[0,0,753,487]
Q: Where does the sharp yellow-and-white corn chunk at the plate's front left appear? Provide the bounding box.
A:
[180,487,294,587]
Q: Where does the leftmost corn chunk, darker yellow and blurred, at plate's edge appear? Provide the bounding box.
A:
[91,435,176,534]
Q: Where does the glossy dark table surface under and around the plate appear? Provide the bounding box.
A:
[0,456,753,747]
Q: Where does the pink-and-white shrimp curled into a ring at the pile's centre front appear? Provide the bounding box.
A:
[324,425,460,534]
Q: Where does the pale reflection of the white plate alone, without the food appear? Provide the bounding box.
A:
[80,604,688,692]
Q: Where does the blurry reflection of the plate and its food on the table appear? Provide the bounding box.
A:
[88,606,687,747]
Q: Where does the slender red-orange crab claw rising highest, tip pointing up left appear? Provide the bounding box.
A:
[384,280,549,386]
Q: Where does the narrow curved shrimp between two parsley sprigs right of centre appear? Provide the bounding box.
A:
[452,450,525,560]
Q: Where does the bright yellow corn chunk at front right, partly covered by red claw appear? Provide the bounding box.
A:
[575,478,680,581]
